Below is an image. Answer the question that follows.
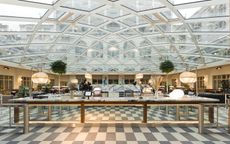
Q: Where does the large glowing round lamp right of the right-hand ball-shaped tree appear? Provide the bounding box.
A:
[180,71,197,83]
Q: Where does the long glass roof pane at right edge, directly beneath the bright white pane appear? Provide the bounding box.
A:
[189,20,229,32]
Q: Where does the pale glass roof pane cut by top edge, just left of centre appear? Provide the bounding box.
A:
[63,0,103,11]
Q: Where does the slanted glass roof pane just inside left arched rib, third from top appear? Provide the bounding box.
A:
[32,34,57,43]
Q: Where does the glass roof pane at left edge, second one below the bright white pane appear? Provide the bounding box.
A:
[0,34,31,45]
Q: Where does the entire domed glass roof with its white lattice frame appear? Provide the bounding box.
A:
[0,0,230,74]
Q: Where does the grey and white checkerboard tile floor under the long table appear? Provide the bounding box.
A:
[0,107,230,144]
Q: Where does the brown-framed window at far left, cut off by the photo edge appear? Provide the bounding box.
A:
[0,75,13,94]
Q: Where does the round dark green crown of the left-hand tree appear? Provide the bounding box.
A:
[50,60,66,74]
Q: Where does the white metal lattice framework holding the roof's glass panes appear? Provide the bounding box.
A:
[0,0,230,74]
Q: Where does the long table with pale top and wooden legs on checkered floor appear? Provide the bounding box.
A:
[11,96,221,133]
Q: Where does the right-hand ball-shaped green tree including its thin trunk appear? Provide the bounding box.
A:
[160,60,174,93]
